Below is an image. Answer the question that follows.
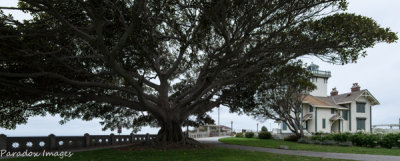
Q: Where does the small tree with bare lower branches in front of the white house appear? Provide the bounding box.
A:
[250,61,315,137]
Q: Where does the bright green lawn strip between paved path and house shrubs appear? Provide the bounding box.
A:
[219,137,400,156]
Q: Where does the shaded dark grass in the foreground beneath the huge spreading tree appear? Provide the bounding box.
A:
[3,147,346,161]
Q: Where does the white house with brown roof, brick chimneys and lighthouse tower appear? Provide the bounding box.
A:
[281,64,379,133]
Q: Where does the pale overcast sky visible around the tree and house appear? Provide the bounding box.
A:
[0,0,400,136]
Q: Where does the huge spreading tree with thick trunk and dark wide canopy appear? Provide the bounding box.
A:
[0,0,397,143]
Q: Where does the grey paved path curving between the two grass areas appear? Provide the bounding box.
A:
[196,137,400,161]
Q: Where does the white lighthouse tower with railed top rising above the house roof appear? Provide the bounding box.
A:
[308,63,331,97]
